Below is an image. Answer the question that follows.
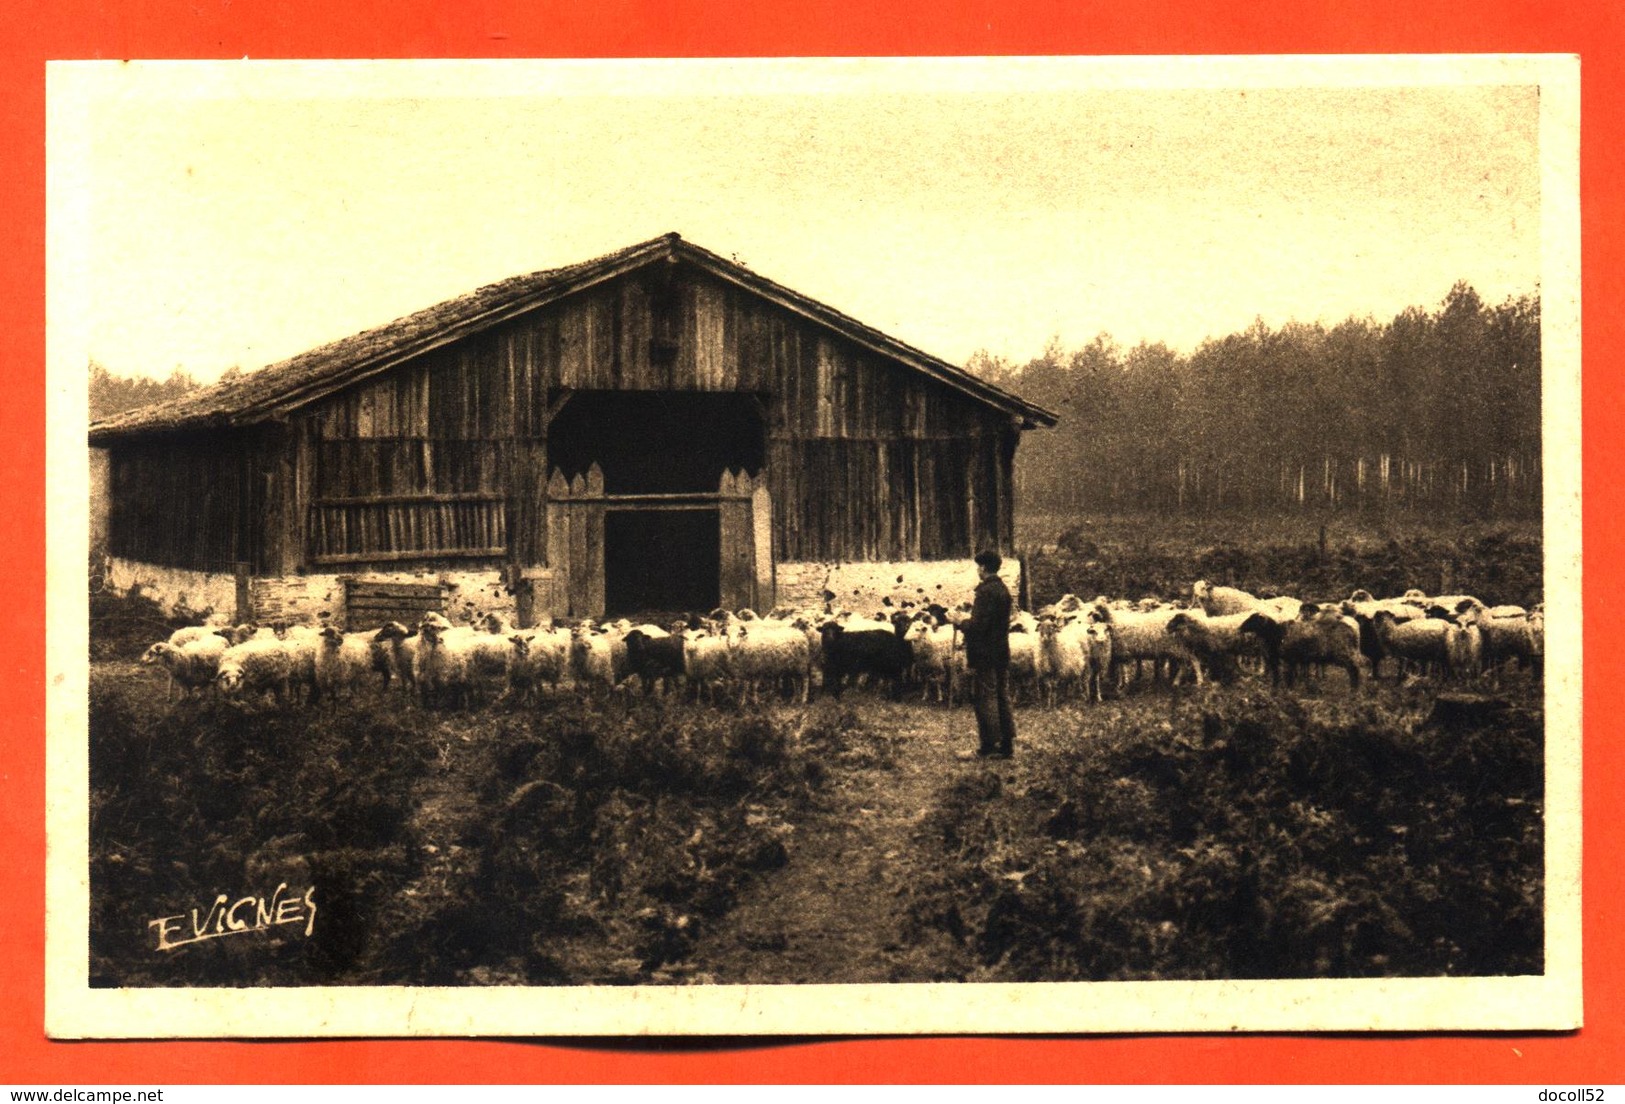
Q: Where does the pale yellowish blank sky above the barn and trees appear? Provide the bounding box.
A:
[50,62,1541,388]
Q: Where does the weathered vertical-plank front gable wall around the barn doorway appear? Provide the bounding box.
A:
[214,265,1011,567]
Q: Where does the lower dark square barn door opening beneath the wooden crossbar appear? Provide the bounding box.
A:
[605,509,722,624]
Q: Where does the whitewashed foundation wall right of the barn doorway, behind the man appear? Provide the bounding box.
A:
[775,559,1021,613]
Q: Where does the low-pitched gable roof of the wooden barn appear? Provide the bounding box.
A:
[89,234,1056,446]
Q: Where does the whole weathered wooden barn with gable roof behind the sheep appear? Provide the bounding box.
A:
[89,234,1055,624]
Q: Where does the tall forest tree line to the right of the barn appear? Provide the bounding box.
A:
[969,283,1541,517]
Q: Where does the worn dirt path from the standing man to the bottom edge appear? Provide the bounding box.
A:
[687,701,1016,984]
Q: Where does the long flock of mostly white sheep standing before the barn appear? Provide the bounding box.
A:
[141,582,1545,707]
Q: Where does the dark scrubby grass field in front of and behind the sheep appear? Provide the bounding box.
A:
[89,519,1544,985]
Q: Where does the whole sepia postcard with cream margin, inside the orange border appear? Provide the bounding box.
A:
[47,55,1581,1037]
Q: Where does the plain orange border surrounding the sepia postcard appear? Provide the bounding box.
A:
[0,0,1625,1084]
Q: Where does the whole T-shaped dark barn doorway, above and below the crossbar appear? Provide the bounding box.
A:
[548,390,767,619]
